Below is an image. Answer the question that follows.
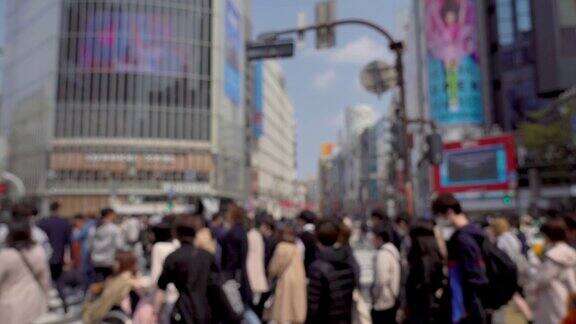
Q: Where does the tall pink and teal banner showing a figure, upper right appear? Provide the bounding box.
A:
[424,0,484,125]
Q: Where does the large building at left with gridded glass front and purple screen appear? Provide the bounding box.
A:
[1,0,250,212]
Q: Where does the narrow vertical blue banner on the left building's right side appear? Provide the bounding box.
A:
[224,0,242,106]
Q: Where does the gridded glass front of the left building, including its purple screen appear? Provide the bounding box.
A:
[55,0,211,140]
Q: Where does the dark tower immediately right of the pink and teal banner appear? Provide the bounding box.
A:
[483,0,545,131]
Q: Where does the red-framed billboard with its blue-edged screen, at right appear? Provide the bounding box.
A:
[434,135,516,192]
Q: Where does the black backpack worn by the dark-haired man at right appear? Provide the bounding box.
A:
[478,238,518,310]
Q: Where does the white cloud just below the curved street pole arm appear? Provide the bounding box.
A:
[328,36,390,64]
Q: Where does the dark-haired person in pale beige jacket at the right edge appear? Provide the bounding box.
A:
[530,219,576,324]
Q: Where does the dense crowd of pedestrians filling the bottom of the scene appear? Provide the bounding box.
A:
[0,194,576,324]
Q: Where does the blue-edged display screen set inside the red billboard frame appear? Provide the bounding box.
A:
[440,145,508,187]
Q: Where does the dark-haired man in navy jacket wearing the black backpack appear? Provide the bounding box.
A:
[432,194,490,324]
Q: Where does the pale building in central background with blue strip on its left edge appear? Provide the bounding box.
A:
[250,61,296,217]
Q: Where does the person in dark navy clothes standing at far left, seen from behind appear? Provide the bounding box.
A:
[37,202,72,282]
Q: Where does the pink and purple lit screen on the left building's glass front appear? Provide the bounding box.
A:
[78,11,186,73]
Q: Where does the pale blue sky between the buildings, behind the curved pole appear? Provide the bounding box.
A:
[252,0,409,178]
